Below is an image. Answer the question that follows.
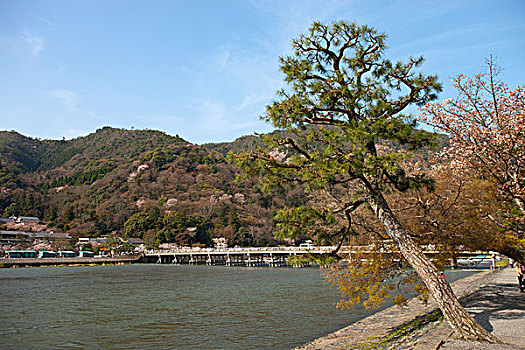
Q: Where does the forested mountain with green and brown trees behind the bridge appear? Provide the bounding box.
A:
[0,127,445,246]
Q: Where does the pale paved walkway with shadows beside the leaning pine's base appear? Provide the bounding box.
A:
[439,268,525,350]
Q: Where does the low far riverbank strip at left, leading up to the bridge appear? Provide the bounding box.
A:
[0,255,142,268]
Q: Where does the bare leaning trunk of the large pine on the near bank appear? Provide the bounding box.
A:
[369,193,501,343]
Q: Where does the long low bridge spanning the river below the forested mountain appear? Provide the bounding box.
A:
[141,246,500,267]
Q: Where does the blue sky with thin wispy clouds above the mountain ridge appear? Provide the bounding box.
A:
[0,0,525,143]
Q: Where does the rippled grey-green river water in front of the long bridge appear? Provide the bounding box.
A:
[0,264,470,349]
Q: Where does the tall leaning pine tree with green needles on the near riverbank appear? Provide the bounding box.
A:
[236,22,497,342]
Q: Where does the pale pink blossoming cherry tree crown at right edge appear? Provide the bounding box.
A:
[420,58,525,216]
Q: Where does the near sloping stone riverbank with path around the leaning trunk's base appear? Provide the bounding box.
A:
[296,268,525,350]
